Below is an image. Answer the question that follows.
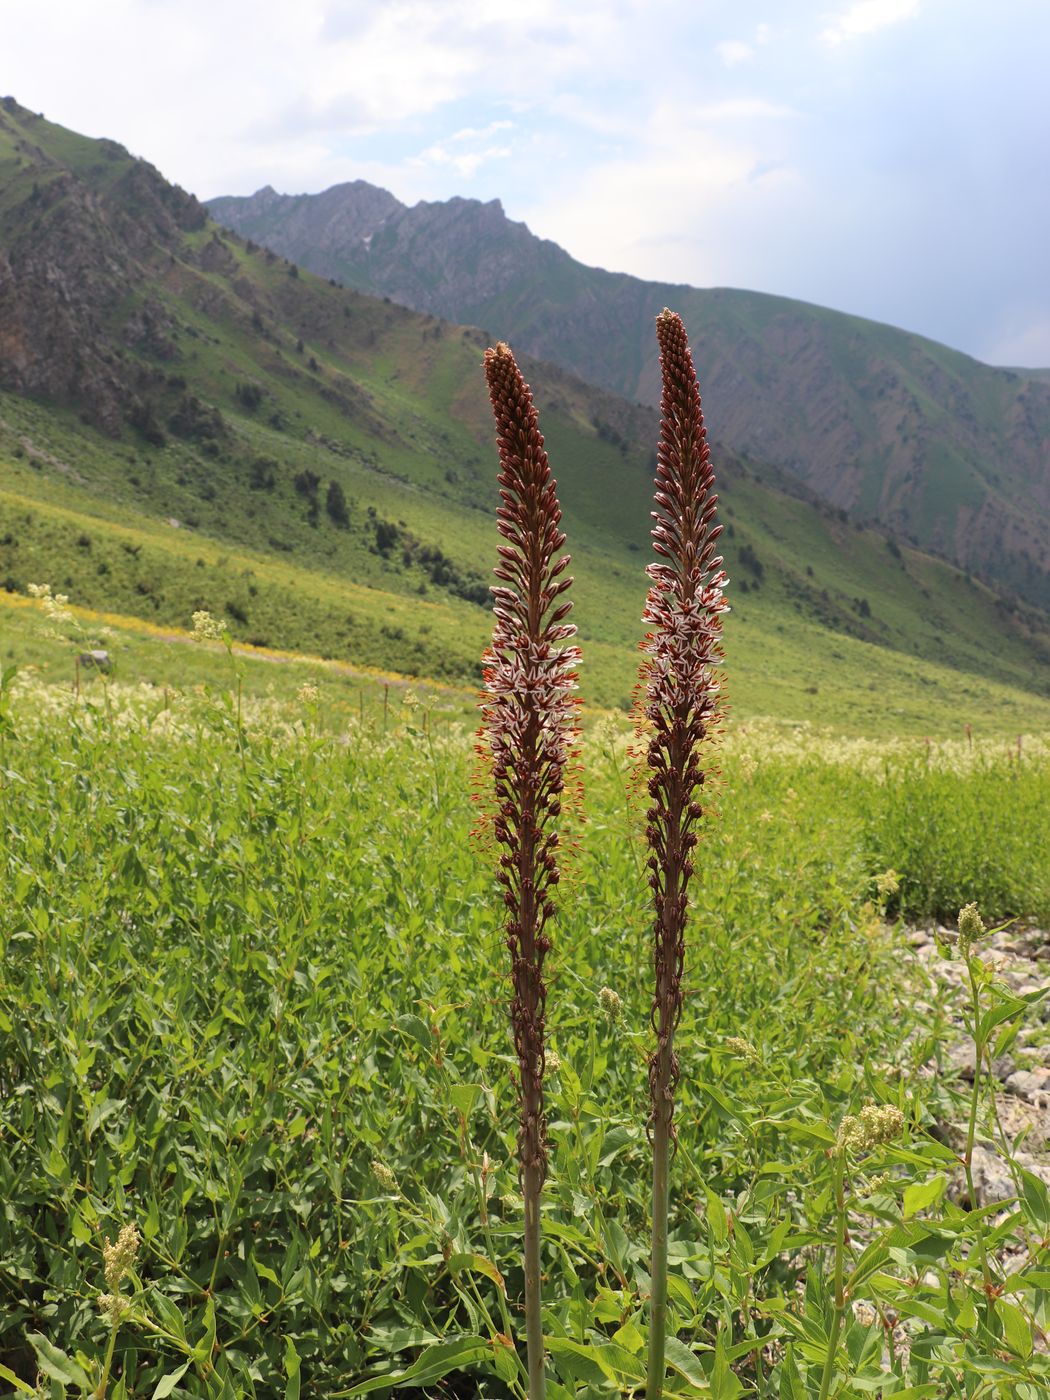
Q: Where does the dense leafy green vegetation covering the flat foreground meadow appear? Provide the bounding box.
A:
[0,624,1050,1400]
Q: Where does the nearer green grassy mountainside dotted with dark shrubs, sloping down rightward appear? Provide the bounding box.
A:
[0,98,1050,732]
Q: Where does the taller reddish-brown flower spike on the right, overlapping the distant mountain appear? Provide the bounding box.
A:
[638,308,728,1400]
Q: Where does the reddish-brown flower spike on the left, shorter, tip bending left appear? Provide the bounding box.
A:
[482,343,580,1400]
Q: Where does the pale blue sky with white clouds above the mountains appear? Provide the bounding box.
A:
[8,0,1050,367]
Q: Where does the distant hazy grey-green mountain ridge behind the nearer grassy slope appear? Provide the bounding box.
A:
[209,181,1050,606]
